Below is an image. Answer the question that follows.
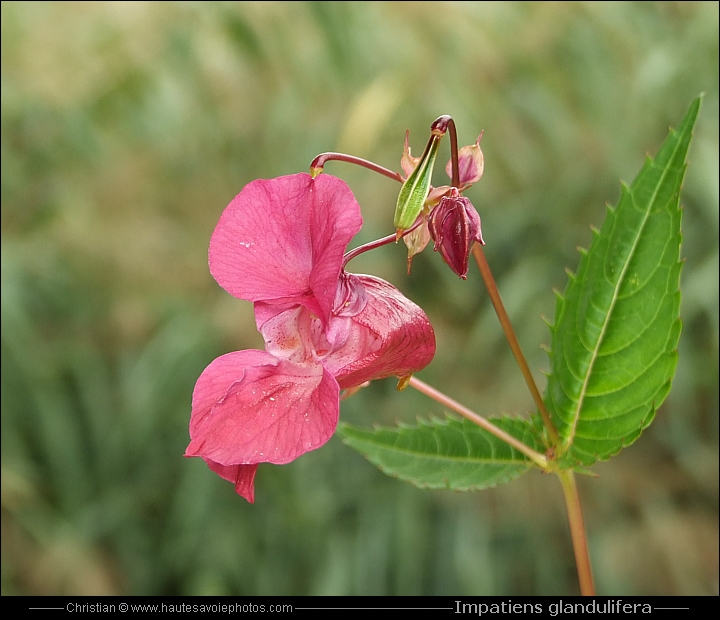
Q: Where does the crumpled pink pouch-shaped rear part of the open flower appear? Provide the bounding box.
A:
[323,276,435,388]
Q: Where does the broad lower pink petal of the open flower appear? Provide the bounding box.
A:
[185,351,339,466]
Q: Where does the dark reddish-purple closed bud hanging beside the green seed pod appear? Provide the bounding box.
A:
[428,187,485,280]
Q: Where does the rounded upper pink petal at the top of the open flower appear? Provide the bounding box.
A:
[209,173,362,319]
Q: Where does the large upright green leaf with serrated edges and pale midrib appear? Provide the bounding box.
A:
[545,98,700,465]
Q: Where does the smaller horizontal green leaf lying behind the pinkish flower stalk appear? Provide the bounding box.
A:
[338,418,543,491]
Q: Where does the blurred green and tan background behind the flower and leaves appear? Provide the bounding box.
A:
[2,2,719,595]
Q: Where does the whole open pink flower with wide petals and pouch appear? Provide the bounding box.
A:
[185,174,435,502]
